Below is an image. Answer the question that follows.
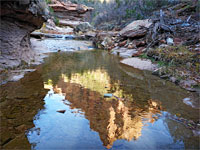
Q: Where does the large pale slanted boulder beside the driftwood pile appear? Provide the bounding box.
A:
[120,19,152,38]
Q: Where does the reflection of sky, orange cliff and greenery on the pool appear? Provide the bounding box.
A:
[28,49,199,149]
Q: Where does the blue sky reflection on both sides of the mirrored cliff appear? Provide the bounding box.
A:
[28,88,184,149]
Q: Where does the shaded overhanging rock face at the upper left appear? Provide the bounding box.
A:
[0,0,48,70]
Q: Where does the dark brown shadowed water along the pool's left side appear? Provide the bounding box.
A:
[0,71,47,149]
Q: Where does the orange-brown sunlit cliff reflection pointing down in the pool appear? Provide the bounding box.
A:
[54,75,160,148]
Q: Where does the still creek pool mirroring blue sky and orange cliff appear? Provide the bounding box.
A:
[0,51,199,150]
